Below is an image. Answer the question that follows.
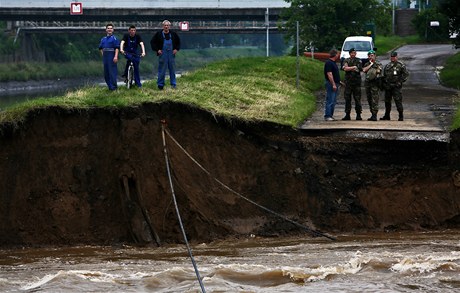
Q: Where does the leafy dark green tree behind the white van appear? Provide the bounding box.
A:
[281,0,391,51]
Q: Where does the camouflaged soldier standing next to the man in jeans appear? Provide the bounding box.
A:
[342,48,363,120]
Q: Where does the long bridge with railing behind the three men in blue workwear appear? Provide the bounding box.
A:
[0,7,282,33]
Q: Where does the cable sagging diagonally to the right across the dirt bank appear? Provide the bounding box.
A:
[163,127,336,240]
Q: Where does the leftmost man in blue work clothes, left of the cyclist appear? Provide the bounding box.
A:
[99,23,120,91]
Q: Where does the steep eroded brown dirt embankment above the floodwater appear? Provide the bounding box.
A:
[0,103,460,246]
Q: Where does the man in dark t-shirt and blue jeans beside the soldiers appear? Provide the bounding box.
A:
[324,49,340,121]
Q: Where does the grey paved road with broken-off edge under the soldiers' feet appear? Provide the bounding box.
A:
[299,45,458,141]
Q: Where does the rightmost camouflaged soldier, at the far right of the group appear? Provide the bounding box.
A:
[380,52,409,121]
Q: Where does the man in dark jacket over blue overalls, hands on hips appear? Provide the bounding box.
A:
[150,20,180,90]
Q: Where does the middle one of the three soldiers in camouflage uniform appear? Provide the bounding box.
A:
[363,50,383,121]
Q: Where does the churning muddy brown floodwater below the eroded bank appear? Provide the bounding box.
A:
[0,230,460,292]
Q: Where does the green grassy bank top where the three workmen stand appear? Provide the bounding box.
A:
[0,57,324,127]
